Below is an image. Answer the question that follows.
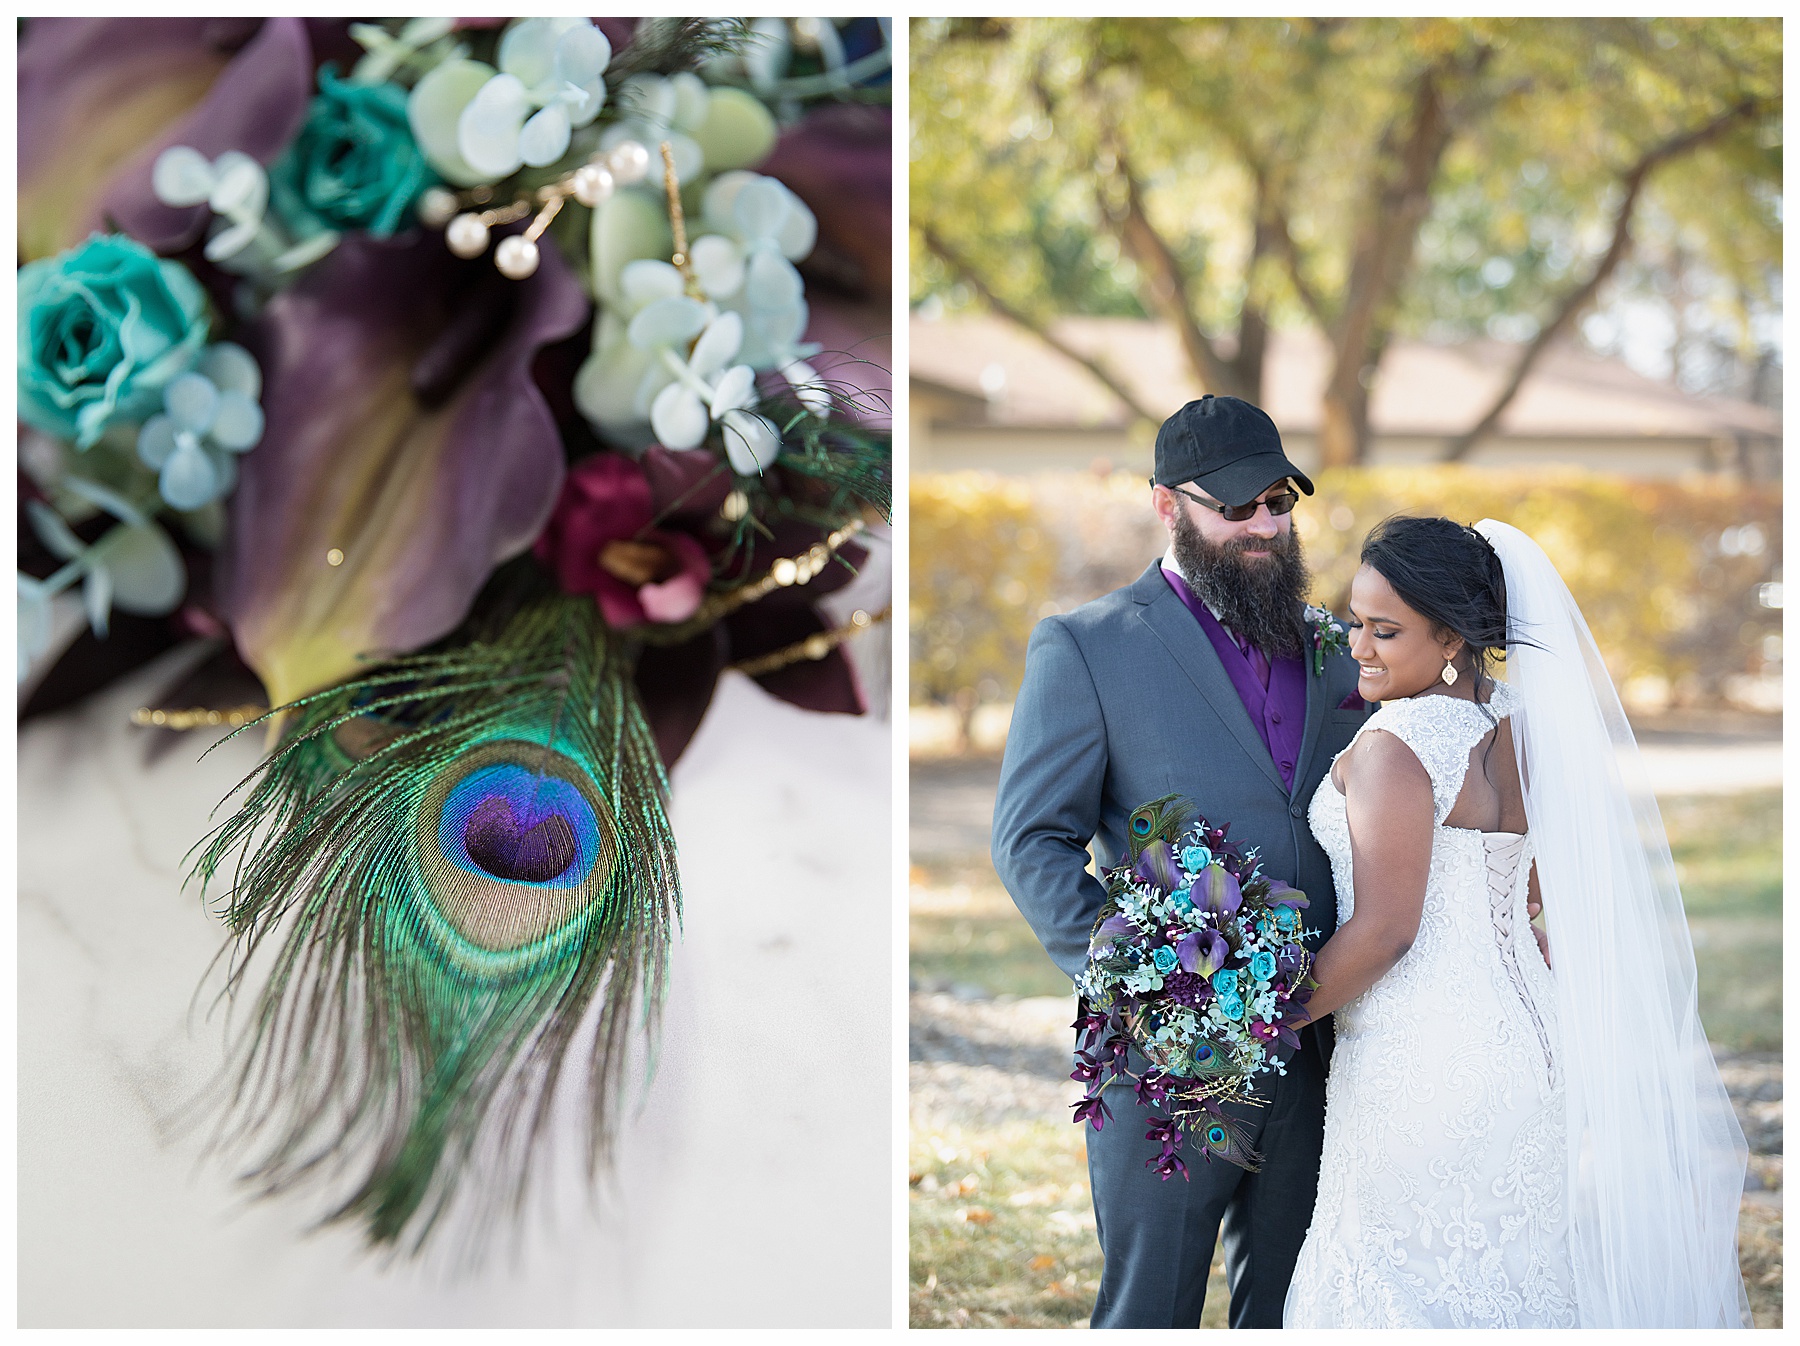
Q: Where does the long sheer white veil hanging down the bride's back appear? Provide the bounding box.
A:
[1476,520,1750,1328]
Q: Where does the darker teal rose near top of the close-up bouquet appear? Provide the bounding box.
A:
[268,68,437,238]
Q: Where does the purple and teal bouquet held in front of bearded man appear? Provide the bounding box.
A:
[1071,795,1314,1180]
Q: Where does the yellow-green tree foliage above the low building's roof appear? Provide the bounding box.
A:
[911,18,1782,394]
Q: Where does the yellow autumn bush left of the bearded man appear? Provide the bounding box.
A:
[911,471,1057,707]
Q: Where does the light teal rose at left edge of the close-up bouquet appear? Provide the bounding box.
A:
[18,234,209,448]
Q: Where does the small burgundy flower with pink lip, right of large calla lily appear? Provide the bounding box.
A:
[536,453,713,626]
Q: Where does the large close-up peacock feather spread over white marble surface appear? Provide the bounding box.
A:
[194,596,680,1251]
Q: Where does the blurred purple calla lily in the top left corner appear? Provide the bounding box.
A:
[18,18,313,261]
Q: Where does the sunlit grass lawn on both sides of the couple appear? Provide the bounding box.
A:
[909,790,1782,1328]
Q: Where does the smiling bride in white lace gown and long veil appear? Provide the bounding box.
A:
[1283,518,1748,1328]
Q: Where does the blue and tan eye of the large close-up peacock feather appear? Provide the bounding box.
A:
[418,740,617,952]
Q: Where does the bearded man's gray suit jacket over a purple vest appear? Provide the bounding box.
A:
[994,561,1368,979]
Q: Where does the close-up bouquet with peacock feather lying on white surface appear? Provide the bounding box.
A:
[18,16,891,1247]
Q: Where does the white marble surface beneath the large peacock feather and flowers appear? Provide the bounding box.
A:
[18,651,895,1326]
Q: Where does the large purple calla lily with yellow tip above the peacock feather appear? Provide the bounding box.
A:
[221,234,587,705]
